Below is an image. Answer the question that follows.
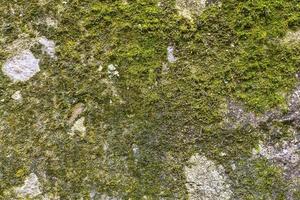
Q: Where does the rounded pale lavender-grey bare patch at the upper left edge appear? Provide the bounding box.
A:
[2,50,40,82]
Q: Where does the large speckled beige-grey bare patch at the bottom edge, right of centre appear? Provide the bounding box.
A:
[184,154,232,200]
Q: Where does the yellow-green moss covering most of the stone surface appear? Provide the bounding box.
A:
[0,0,300,200]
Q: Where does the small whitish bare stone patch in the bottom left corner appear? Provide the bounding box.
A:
[15,173,42,198]
